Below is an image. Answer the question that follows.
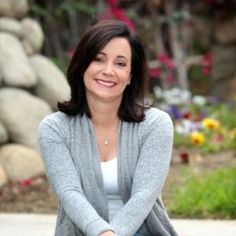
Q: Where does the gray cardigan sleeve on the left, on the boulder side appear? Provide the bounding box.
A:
[39,119,114,236]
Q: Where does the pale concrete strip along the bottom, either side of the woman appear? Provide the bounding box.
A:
[0,213,236,236]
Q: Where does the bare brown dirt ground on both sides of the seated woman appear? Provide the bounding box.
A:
[0,150,236,214]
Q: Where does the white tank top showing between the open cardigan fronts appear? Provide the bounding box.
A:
[101,158,123,220]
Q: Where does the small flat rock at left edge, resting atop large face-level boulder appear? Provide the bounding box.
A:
[0,17,22,38]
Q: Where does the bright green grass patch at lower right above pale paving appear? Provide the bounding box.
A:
[167,168,236,219]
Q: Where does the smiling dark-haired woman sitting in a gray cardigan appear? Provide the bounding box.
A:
[39,21,176,236]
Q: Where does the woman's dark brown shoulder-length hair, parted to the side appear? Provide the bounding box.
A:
[58,20,148,122]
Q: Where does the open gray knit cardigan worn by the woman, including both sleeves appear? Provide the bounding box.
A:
[39,108,177,236]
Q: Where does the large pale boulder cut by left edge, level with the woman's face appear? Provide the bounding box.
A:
[0,32,37,88]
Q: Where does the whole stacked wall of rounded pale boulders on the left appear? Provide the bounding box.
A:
[0,0,70,187]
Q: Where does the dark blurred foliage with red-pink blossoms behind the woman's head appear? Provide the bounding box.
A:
[29,0,236,99]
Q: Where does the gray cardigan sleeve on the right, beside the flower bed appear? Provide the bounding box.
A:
[110,109,173,236]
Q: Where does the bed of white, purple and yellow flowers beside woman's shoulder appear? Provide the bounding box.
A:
[154,87,236,153]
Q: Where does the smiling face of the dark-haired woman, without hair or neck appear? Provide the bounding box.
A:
[84,37,131,101]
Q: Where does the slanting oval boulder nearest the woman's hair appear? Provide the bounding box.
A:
[30,55,70,110]
